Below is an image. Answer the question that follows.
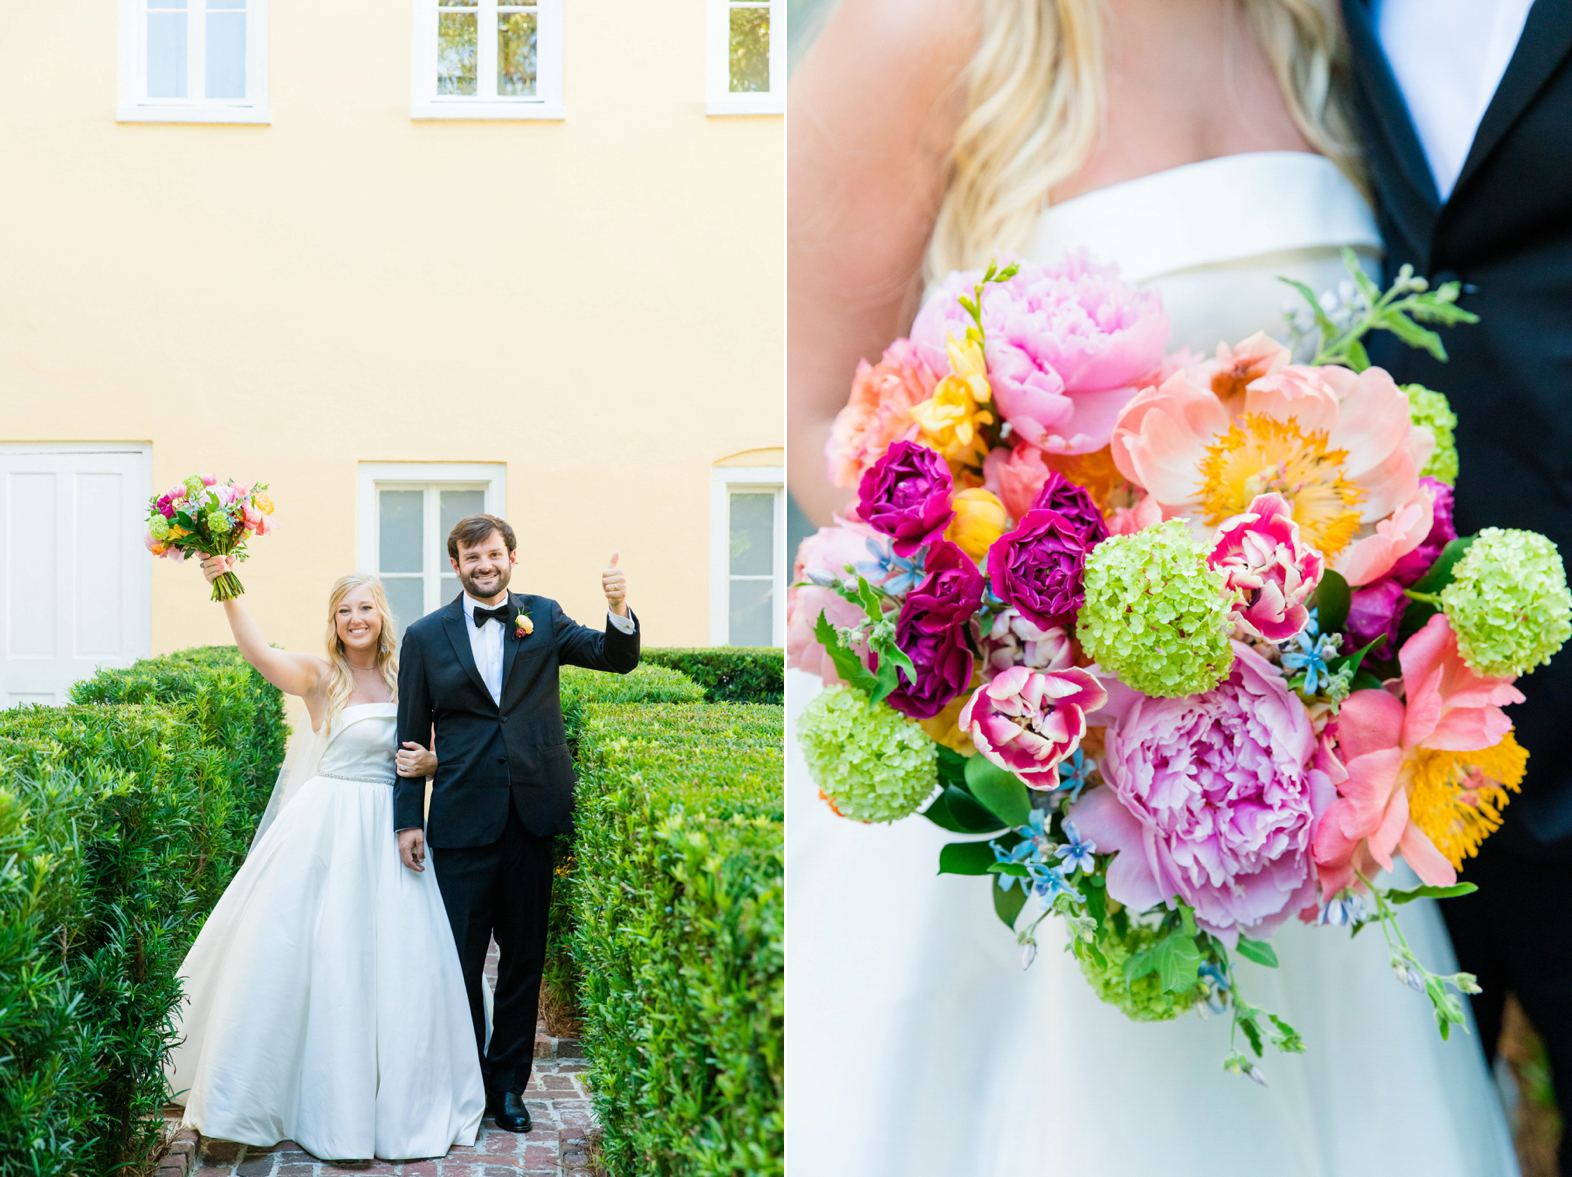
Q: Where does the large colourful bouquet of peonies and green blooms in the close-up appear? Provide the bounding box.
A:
[788,255,1572,1080]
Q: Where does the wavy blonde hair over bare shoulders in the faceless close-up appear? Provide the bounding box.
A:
[924,0,1363,281]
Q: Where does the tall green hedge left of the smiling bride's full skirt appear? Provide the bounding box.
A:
[0,651,286,1177]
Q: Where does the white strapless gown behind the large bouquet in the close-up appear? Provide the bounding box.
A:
[786,152,1517,1177]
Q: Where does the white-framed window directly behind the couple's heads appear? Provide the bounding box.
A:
[355,462,508,636]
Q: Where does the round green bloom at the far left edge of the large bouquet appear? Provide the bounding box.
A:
[797,687,938,822]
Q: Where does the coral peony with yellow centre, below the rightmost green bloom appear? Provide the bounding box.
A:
[1314,616,1523,897]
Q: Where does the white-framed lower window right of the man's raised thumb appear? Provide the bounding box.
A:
[709,465,786,646]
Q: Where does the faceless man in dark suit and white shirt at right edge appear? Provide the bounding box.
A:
[1342,0,1572,1172]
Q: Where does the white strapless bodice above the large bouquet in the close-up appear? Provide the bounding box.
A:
[1023,151,1380,354]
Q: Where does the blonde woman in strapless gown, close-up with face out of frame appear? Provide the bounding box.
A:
[786,0,1517,1177]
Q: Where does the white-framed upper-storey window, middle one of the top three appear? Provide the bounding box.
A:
[410,0,566,118]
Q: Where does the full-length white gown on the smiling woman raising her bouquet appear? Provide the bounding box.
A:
[170,702,486,1160]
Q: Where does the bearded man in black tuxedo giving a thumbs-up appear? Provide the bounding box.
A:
[393,515,638,1131]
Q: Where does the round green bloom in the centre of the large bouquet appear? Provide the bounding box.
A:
[1075,519,1234,698]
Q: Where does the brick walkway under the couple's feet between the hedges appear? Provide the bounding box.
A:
[157,944,594,1177]
